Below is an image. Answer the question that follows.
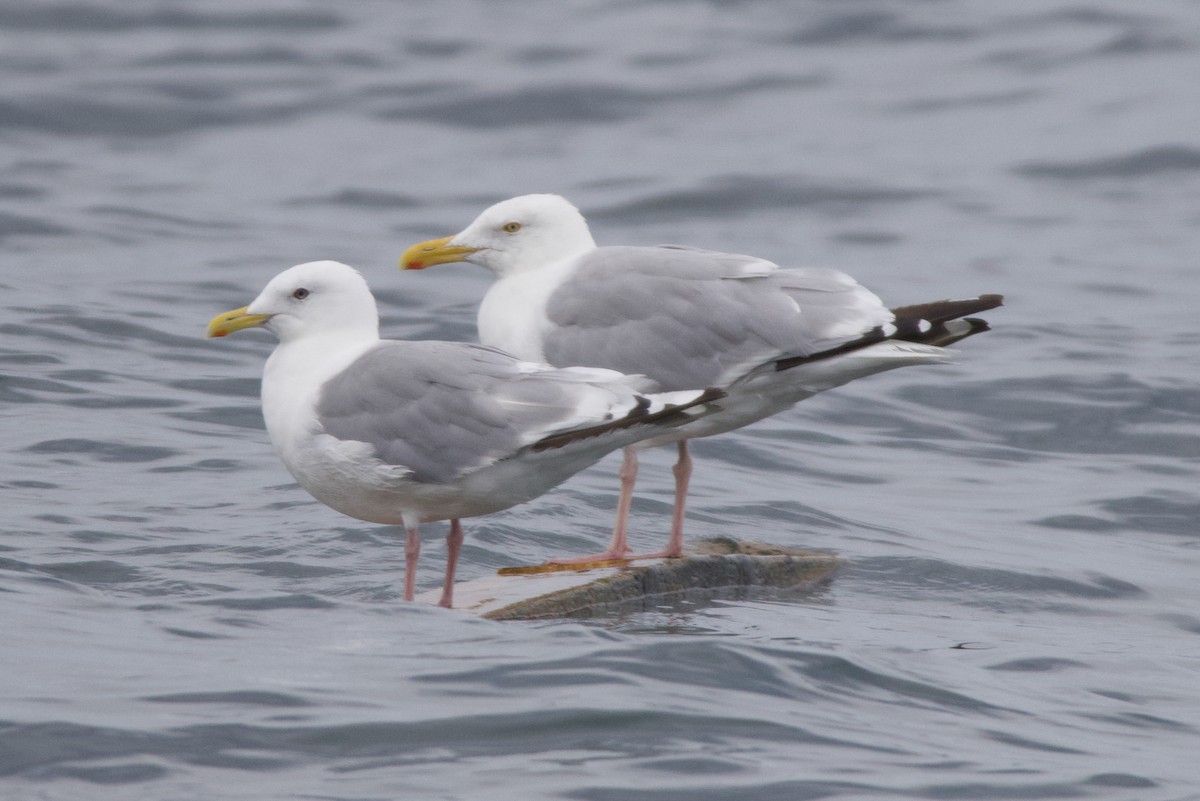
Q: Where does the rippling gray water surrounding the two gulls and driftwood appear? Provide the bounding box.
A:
[0,0,1200,801]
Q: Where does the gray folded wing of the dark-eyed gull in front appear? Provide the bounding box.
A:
[317,342,638,483]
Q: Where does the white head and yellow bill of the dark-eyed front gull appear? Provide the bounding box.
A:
[209,261,379,342]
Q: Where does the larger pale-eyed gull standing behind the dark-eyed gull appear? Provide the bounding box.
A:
[400,194,1002,564]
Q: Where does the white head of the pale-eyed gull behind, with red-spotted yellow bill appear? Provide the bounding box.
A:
[400,194,595,277]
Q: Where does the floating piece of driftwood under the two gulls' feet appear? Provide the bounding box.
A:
[421,537,838,620]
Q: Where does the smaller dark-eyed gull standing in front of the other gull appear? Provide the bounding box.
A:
[208,261,724,607]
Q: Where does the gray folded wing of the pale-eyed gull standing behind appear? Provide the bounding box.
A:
[545,246,892,390]
